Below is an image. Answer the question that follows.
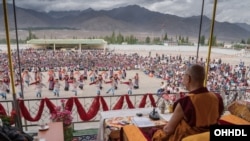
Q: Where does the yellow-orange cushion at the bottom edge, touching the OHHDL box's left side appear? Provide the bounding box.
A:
[182,132,210,141]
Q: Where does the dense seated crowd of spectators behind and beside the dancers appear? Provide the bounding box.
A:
[0,49,250,101]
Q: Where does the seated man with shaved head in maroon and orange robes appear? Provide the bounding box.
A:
[152,64,224,141]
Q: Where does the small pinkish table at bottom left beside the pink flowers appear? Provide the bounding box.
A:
[38,122,64,141]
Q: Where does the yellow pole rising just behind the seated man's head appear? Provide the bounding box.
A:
[204,0,217,86]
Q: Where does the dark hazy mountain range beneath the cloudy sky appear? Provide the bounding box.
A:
[0,4,250,42]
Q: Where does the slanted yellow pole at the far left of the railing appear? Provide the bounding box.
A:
[3,0,22,130]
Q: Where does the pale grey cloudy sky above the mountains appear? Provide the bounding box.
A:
[8,0,250,25]
